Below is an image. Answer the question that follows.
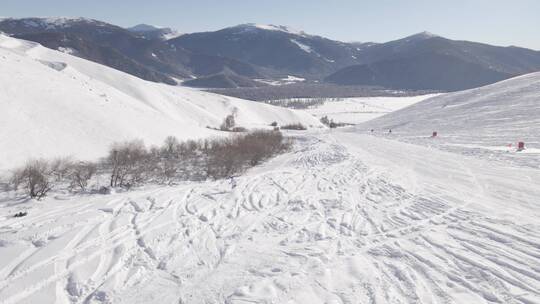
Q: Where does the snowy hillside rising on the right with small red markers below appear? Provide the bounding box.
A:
[358,73,540,168]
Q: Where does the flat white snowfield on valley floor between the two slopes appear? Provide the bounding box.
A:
[306,94,436,124]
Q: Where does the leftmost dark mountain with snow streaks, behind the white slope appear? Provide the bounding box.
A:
[0,18,260,85]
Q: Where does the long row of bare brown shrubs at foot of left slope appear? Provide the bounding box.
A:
[5,130,292,199]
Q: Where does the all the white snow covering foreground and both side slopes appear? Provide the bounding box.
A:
[0,36,540,304]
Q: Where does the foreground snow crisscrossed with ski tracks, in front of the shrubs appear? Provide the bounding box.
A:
[0,131,540,304]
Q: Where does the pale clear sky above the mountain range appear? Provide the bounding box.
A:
[4,0,540,50]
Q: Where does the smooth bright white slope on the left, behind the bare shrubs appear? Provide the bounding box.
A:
[0,35,319,169]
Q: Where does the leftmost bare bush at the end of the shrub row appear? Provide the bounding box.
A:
[11,160,54,200]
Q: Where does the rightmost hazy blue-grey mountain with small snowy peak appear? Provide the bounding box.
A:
[326,32,540,91]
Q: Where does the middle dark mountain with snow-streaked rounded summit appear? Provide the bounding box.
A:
[169,23,359,79]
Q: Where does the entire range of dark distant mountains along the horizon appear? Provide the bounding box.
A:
[0,17,540,91]
